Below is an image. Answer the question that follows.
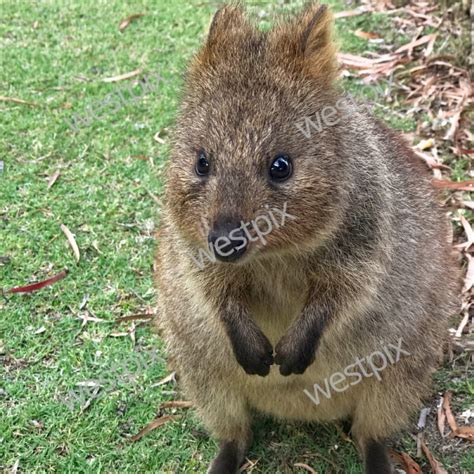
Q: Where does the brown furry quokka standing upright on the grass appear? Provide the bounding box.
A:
[156,4,457,474]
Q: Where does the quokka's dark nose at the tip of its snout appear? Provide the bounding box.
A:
[207,219,248,262]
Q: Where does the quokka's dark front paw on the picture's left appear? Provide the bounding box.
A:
[234,330,273,377]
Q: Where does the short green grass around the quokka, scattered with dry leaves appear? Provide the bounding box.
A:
[0,0,474,474]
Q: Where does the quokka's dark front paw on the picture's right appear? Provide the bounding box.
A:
[275,334,316,375]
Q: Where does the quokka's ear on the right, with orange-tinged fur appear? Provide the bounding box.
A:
[271,3,338,83]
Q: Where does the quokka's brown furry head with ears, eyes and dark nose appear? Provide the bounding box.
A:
[167,1,343,262]
